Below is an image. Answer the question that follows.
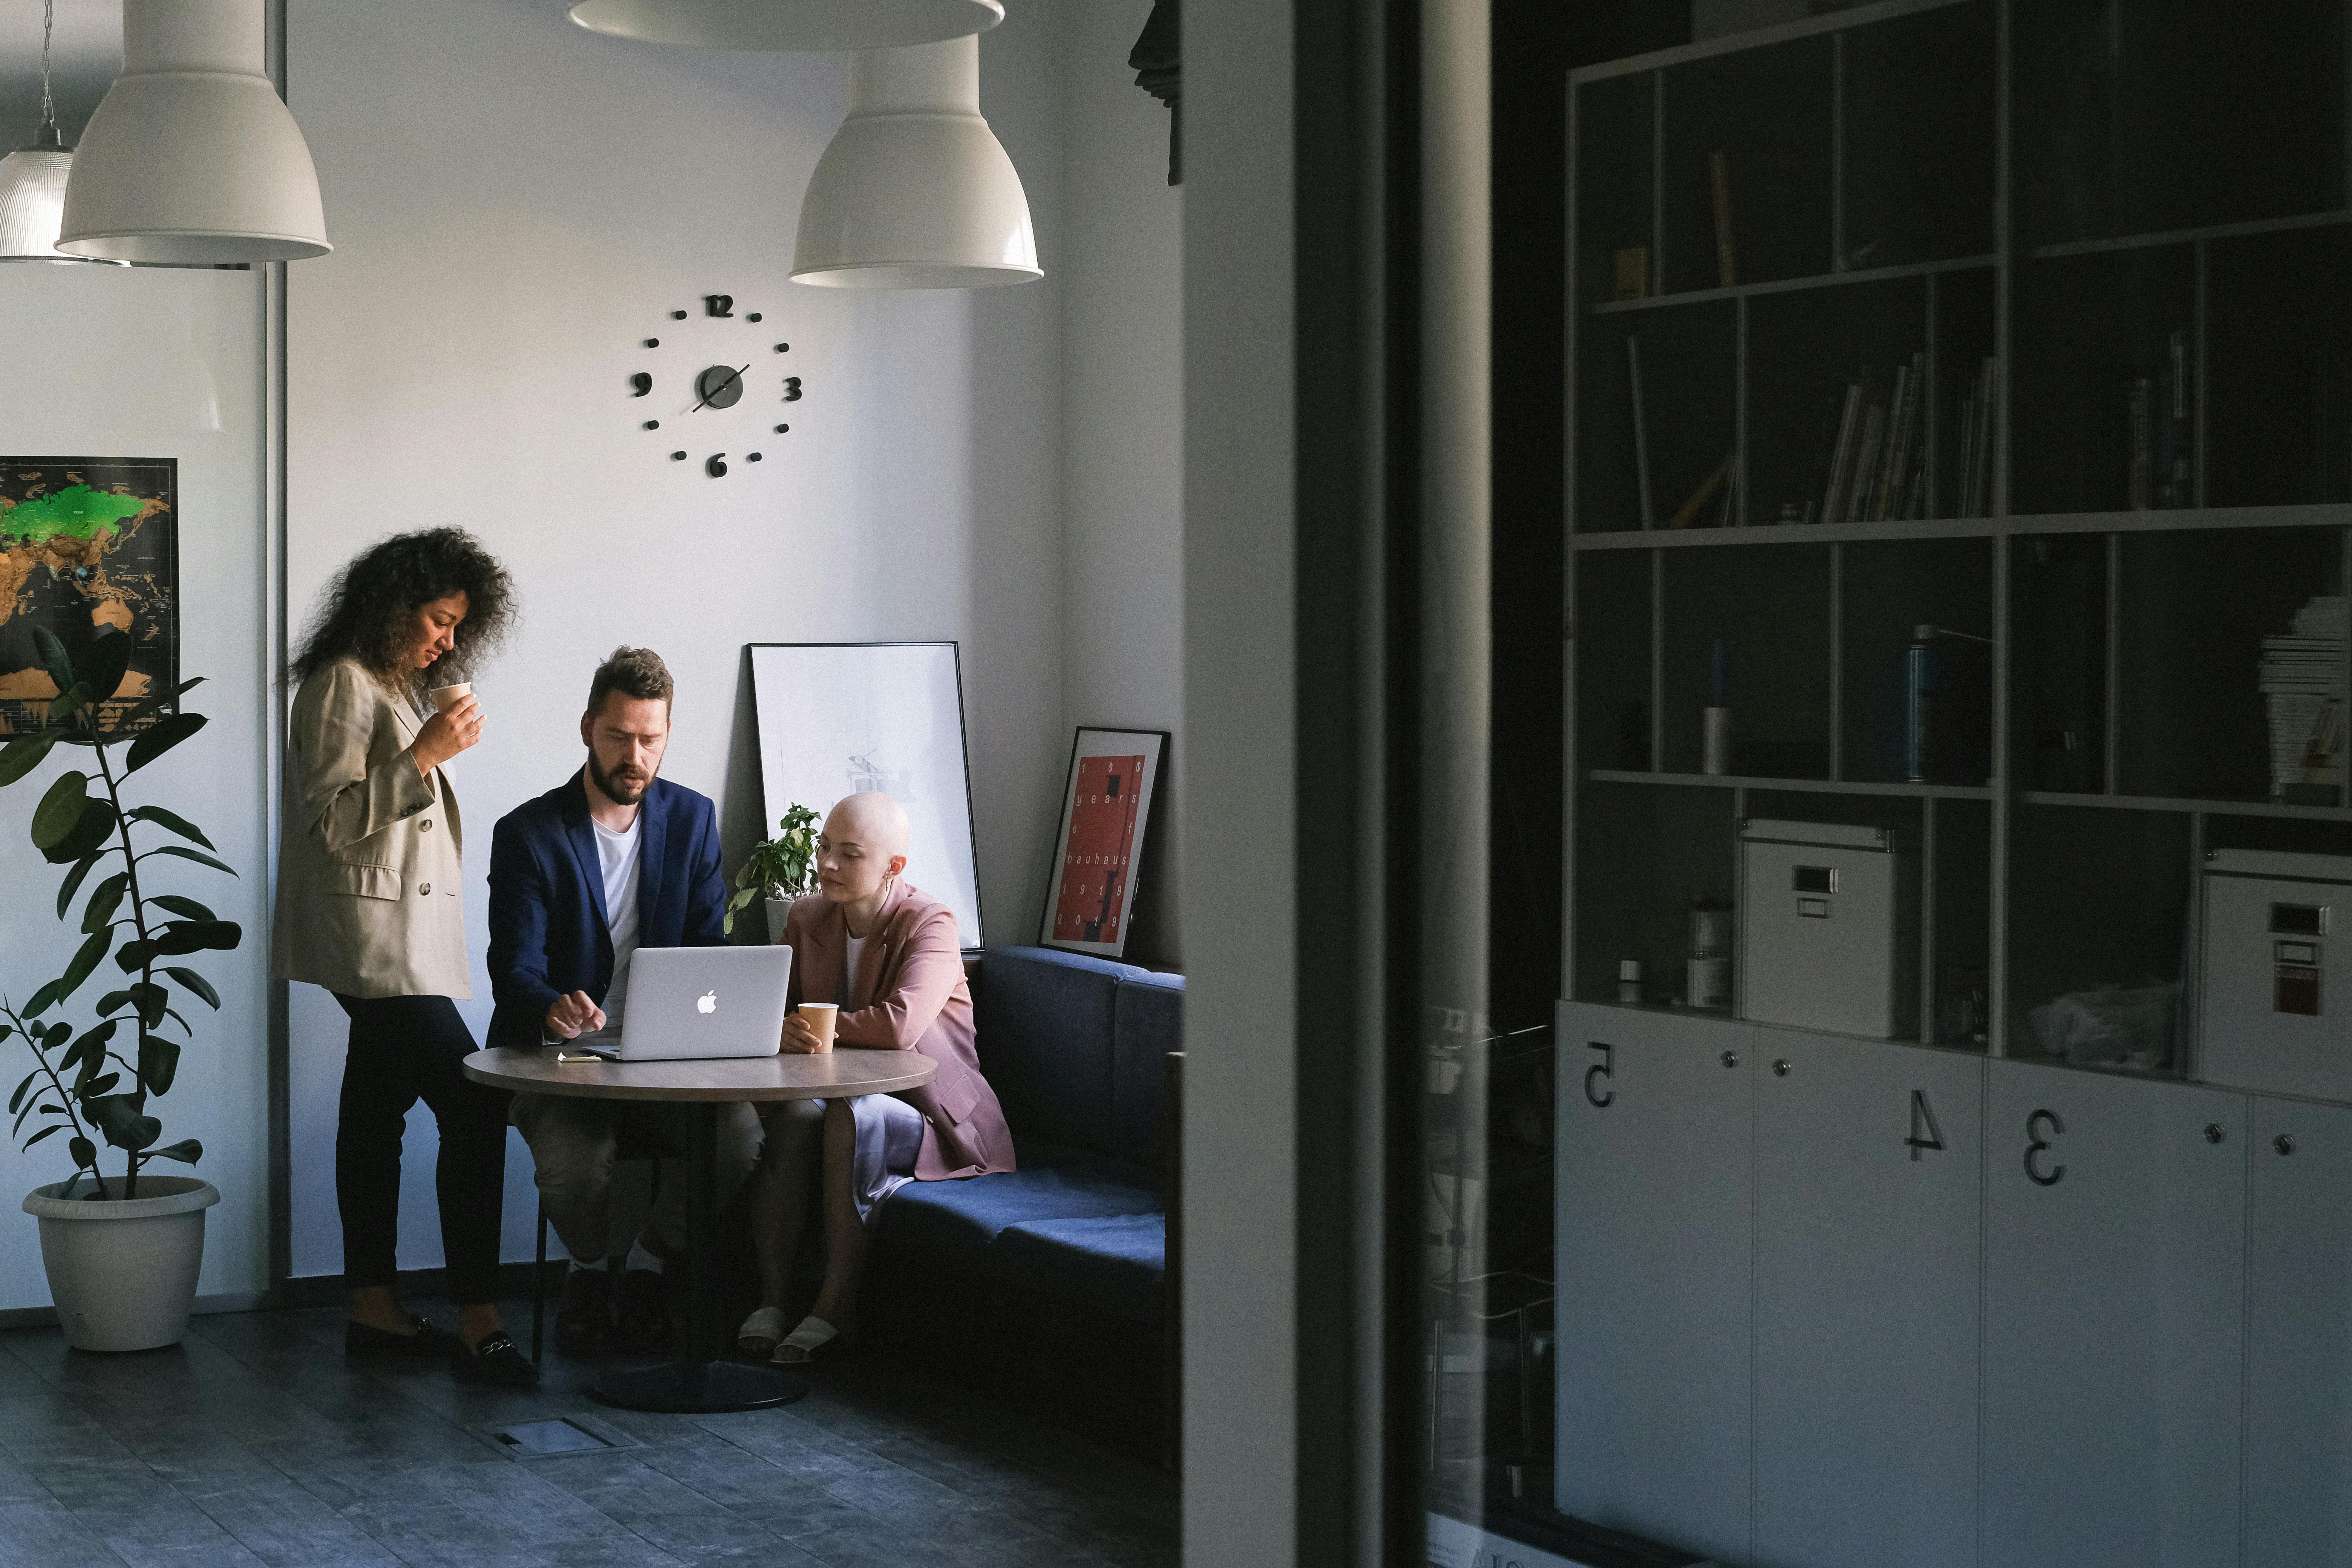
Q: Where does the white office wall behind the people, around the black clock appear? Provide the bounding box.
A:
[0,0,1185,1309]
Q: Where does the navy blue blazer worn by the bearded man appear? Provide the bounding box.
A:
[489,773,727,1046]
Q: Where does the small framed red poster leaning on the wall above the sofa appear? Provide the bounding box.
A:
[1037,726,1169,959]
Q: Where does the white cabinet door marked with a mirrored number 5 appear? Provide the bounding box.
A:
[1555,1001,1755,1563]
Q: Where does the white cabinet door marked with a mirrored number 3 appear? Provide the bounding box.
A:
[1980,1060,2248,1568]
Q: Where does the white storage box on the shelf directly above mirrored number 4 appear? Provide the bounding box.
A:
[1738,818,1919,1039]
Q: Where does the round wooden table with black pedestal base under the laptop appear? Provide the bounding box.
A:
[466,1046,939,1415]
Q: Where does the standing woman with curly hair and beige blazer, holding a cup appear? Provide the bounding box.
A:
[271,529,539,1387]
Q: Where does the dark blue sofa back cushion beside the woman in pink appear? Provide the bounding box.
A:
[978,947,1145,1157]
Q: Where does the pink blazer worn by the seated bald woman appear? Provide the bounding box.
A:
[783,879,1014,1182]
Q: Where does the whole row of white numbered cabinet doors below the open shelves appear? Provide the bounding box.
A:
[1555,1004,2352,1568]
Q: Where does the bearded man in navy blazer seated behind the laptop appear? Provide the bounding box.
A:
[489,649,760,1357]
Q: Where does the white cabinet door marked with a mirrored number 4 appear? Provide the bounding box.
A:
[1750,1030,1985,1568]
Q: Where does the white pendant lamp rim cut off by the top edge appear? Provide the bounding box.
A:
[571,0,1004,52]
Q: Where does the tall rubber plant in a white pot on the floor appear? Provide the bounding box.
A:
[0,628,242,1349]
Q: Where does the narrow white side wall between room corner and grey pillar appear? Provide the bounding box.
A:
[1061,0,1190,969]
